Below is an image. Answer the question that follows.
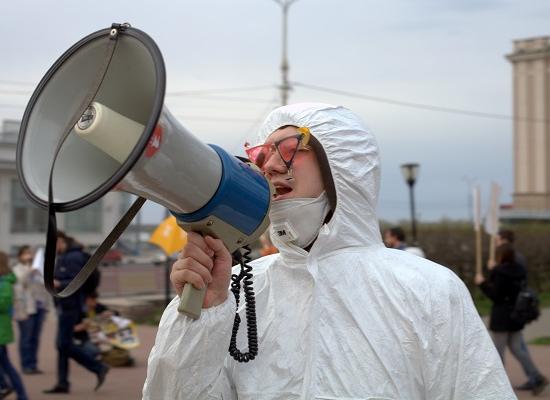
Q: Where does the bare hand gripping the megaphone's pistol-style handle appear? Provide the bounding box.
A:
[170,232,232,319]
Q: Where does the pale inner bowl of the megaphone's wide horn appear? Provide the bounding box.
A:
[17,28,166,211]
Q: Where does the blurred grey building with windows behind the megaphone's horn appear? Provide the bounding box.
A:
[0,120,130,254]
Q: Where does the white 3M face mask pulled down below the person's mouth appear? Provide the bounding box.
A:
[269,192,330,249]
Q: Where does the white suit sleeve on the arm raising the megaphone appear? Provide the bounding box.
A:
[143,293,237,400]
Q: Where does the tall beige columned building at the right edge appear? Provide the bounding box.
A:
[503,36,550,220]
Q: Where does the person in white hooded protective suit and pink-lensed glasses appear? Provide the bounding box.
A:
[143,103,516,400]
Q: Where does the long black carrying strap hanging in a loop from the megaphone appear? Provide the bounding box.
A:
[44,23,145,297]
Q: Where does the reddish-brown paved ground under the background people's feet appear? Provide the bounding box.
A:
[4,309,550,400]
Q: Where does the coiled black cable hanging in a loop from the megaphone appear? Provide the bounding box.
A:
[229,246,258,362]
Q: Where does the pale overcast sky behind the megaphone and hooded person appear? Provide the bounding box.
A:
[0,0,550,222]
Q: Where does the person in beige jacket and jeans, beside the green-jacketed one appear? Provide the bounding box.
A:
[13,245,48,375]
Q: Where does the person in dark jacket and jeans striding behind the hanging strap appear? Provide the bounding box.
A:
[44,231,109,394]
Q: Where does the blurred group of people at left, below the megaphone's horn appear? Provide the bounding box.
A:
[0,231,139,400]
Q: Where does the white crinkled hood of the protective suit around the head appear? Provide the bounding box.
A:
[258,103,382,255]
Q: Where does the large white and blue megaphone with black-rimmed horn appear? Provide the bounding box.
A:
[17,24,272,332]
